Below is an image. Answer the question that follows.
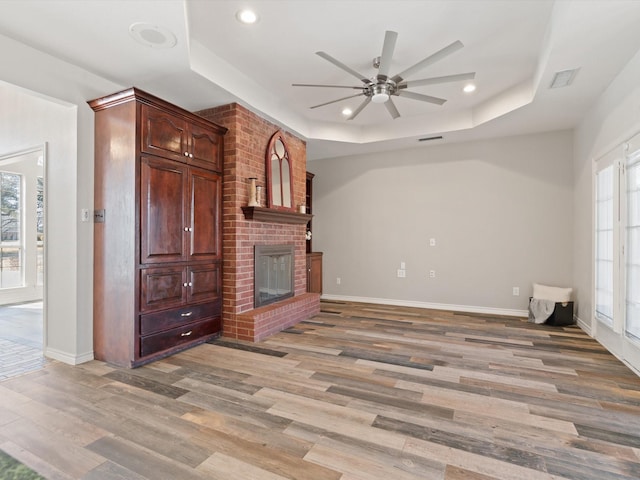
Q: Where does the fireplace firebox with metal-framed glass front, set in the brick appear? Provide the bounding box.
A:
[253,245,295,308]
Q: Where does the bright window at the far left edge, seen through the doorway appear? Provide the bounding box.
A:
[0,172,24,288]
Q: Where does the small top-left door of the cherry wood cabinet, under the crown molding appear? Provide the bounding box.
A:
[141,105,189,162]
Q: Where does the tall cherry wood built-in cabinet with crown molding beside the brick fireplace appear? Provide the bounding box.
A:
[89,88,226,367]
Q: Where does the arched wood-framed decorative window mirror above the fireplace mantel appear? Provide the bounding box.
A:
[266,130,295,210]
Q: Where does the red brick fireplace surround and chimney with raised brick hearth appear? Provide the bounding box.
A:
[197,103,320,342]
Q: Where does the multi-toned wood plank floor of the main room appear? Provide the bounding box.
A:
[0,302,640,480]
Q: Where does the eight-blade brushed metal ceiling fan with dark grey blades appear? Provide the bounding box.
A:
[292,30,476,120]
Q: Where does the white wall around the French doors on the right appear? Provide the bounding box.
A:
[573,48,640,330]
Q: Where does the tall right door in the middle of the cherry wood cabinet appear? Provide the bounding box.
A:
[189,168,222,260]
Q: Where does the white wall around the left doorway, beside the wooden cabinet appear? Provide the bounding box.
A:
[0,35,122,363]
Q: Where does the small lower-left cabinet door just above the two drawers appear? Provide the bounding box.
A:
[140,267,187,312]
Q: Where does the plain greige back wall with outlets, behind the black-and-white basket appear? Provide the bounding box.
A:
[307,131,573,314]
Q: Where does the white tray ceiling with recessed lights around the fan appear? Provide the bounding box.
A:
[0,0,640,160]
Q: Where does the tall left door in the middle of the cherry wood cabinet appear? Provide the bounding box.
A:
[140,157,190,264]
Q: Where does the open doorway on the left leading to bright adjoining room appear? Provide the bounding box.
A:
[0,145,47,380]
